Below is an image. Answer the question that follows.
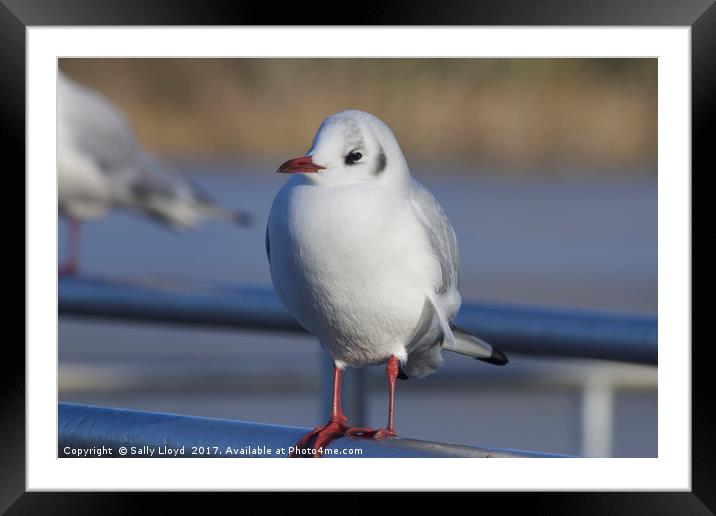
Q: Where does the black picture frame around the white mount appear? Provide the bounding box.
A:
[8,0,716,515]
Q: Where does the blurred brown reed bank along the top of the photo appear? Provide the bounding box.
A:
[60,59,657,175]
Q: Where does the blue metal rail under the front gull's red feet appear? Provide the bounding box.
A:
[58,403,565,458]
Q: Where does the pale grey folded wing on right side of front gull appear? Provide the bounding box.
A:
[413,181,460,296]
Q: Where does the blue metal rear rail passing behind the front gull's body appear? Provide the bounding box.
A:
[59,278,658,365]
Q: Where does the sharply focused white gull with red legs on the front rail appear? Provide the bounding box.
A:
[266,110,508,456]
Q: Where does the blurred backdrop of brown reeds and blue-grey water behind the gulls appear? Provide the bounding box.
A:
[58,59,658,457]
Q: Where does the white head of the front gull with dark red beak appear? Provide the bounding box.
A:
[278,110,410,185]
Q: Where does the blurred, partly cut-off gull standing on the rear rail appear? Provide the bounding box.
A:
[57,72,250,274]
